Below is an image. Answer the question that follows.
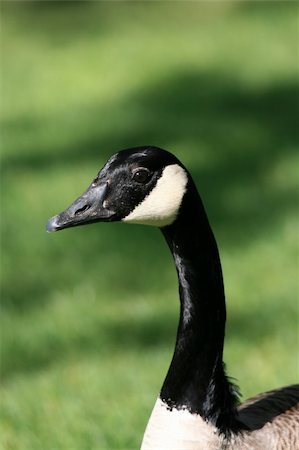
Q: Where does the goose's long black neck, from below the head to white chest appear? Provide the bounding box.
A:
[161,181,237,432]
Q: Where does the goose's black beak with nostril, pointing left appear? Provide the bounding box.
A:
[47,183,115,232]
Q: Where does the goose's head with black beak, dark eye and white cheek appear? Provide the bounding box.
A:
[47,147,189,231]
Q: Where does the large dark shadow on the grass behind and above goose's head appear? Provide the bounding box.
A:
[4,71,299,171]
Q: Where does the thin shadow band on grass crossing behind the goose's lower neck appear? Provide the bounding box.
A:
[1,296,296,382]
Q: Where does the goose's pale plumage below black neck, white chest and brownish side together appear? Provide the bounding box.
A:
[141,398,282,450]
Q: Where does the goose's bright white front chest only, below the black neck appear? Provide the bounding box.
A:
[141,398,221,450]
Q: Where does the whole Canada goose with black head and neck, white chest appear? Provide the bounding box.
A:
[47,147,299,450]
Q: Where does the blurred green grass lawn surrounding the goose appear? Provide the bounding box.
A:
[0,1,298,450]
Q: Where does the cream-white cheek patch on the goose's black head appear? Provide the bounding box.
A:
[122,164,188,227]
